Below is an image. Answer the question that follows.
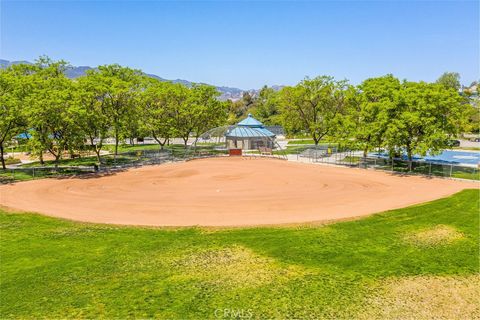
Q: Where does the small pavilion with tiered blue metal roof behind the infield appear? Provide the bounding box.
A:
[225,114,275,150]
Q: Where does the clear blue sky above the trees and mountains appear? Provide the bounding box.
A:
[0,0,480,89]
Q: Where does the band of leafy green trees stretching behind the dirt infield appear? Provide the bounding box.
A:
[0,57,472,172]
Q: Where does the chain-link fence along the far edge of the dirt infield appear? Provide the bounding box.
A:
[0,144,480,183]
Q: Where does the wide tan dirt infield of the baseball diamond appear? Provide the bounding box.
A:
[0,158,476,226]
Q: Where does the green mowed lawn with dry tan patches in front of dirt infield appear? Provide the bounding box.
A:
[0,190,480,319]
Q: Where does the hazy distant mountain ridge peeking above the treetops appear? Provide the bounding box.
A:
[0,59,283,101]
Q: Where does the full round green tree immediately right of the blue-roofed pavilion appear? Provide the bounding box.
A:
[280,76,349,145]
